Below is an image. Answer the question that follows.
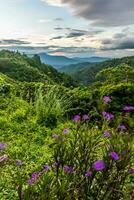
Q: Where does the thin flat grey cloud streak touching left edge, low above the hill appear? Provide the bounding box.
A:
[0,39,30,45]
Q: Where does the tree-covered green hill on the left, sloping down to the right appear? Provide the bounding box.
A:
[0,50,76,86]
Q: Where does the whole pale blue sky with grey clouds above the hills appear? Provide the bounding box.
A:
[0,0,134,57]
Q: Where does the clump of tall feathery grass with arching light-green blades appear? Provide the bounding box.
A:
[35,86,72,126]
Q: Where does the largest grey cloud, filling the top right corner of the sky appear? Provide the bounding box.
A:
[44,0,134,26]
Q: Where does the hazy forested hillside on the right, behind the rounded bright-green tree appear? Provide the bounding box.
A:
[61,56,134,85]
